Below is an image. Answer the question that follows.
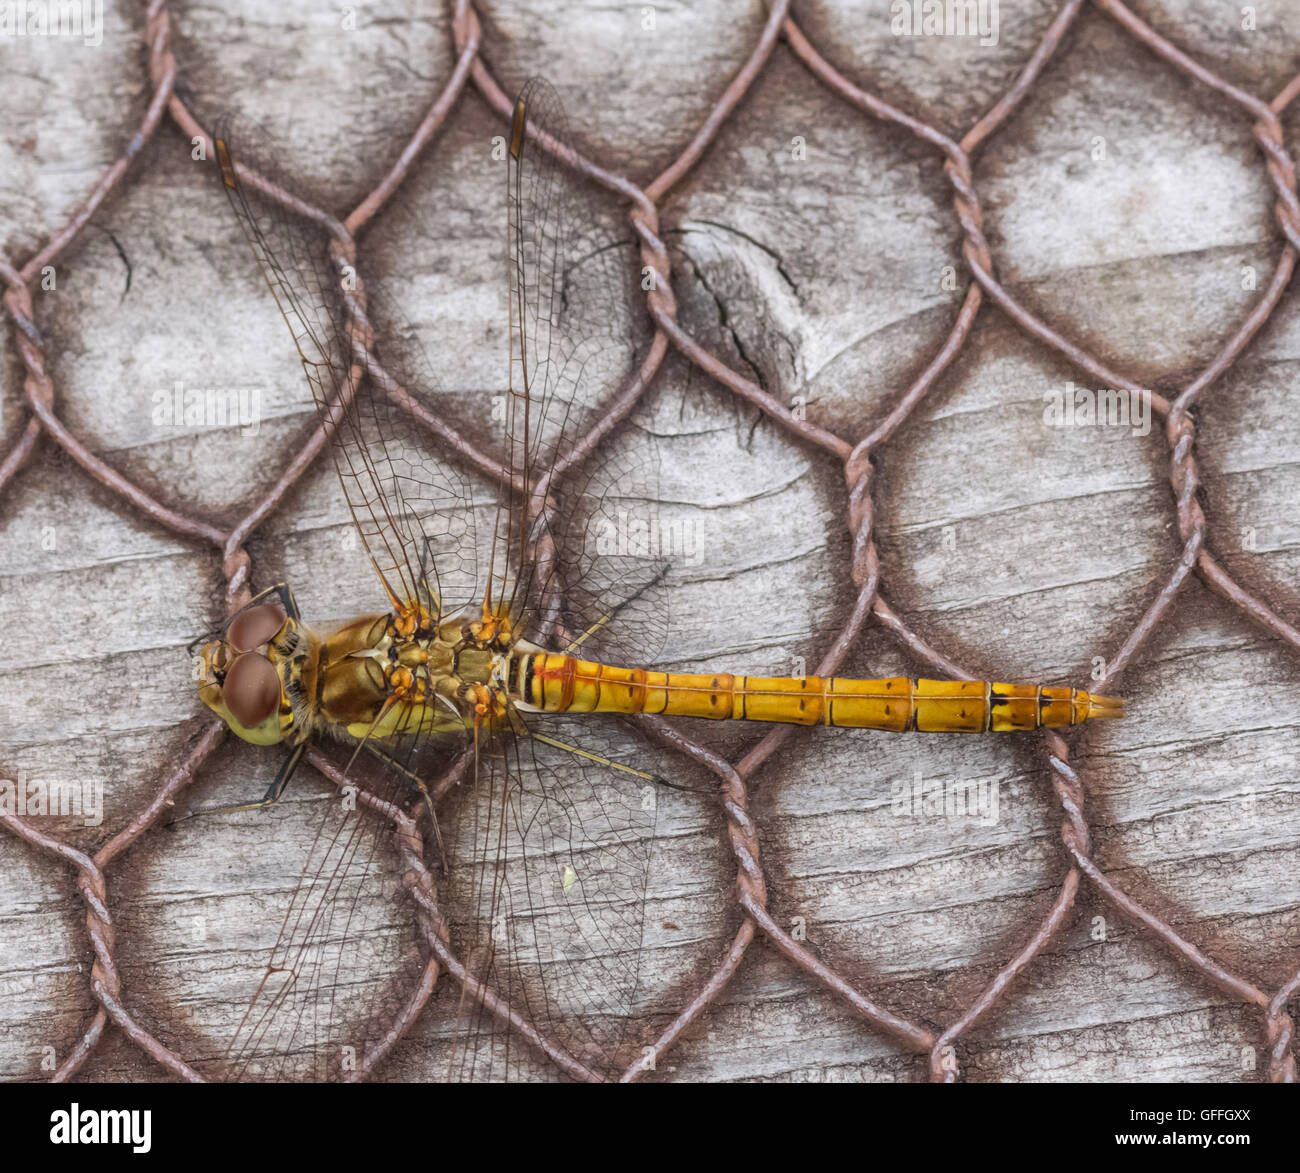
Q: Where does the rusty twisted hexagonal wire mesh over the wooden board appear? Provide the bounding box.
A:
[0,0,1300,1082]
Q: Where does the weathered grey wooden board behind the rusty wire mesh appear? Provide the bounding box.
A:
[0,0,1300,1082]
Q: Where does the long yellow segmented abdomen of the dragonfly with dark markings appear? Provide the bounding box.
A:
[519,653,1123,733]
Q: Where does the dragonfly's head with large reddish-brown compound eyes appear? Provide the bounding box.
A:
[195,603,298,745]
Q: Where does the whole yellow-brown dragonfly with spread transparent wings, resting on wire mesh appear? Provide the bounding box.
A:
[196,79,1123,1079]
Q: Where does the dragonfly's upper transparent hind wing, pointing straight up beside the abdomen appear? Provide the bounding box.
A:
[493,79,668,659]
